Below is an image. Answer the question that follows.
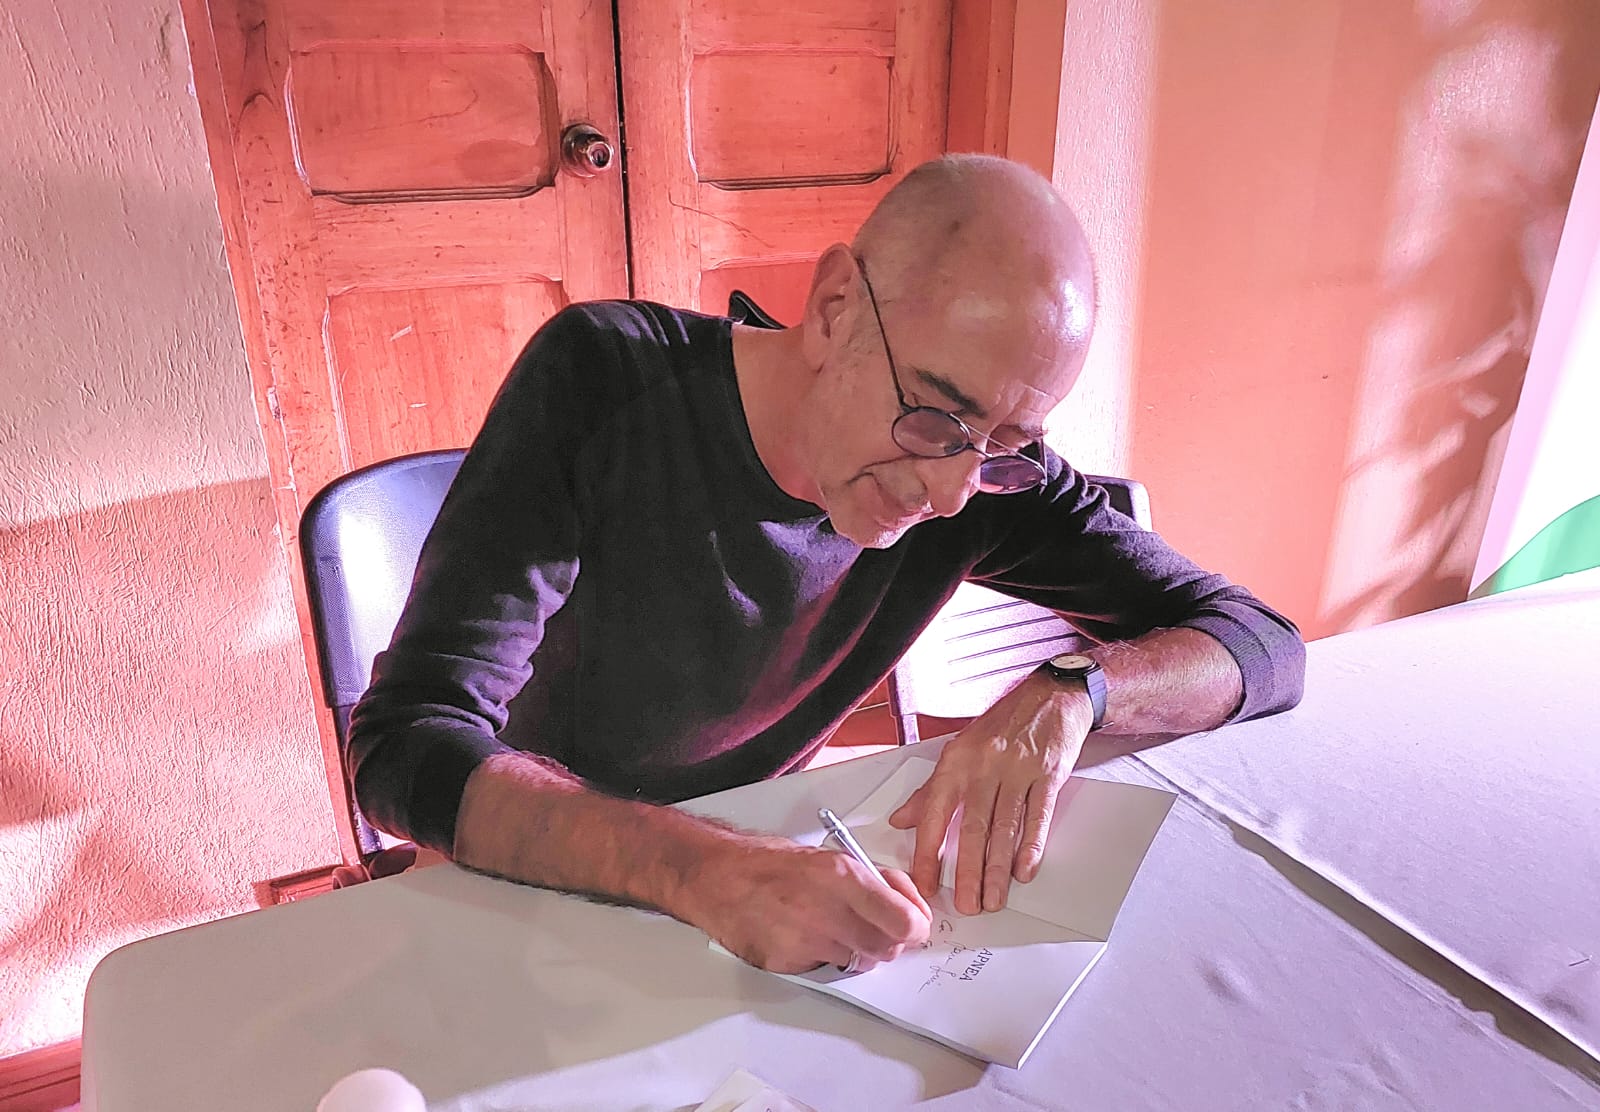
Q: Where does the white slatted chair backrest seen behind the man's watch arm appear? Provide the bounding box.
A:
[890,475,1150,744]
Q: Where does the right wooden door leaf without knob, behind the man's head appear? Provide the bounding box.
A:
[618,0,950,322]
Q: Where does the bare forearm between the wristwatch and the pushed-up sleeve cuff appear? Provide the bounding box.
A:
[1090,627,1245,734]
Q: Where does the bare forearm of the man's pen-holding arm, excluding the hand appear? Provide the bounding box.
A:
[454,754,742,923]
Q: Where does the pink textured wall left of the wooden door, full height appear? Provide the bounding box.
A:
[0,0,336,1056]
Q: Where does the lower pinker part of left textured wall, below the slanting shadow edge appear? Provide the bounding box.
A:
[0,480,336,1054]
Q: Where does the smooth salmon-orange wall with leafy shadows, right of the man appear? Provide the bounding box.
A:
[1131,0,1600,637]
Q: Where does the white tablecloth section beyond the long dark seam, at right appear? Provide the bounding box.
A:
[1142,570,1600,1068]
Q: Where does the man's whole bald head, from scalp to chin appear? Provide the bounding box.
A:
[792,155,1094,547]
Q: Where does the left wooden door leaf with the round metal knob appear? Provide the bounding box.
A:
[184,0,627,858]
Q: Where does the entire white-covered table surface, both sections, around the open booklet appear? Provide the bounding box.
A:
[83,578,1600,1112]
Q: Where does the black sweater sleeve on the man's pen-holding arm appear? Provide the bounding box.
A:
[346,307,606,853]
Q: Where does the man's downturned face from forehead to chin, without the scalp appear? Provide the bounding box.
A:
[810,261,1088,549]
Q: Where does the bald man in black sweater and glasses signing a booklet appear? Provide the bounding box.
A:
[347,155,1304,971]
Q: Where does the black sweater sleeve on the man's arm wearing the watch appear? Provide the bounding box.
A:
[970,451,1306,722]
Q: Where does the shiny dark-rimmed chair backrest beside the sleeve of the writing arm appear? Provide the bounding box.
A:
[299,450,466,854]
